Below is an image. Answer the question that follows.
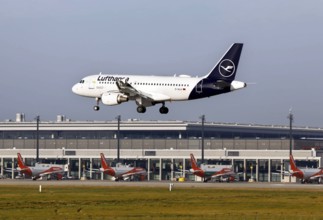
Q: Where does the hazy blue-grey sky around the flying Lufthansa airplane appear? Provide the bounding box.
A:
[0,0,323,127]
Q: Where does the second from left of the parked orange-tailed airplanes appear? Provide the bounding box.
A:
[100,153,147,181]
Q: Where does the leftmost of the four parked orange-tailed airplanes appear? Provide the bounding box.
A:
[17,153,68,180]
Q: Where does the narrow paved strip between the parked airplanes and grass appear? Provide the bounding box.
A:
[0,179,323,191]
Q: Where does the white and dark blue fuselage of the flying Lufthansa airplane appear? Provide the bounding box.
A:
[72,75,246,101]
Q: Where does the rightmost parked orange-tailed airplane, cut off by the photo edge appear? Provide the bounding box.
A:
[289,155,323,183]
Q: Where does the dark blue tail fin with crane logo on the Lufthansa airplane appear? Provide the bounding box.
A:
[205,43,243,83]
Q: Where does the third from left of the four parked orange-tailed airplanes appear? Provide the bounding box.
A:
[190,154,235,182]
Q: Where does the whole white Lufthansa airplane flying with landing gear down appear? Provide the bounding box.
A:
[72,43,247,114]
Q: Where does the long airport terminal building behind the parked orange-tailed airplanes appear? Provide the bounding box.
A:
[0,114,323,182]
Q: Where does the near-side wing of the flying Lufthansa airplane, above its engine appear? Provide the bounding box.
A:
[116,80,170,102]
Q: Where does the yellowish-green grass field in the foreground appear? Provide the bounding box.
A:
[0,186,323,220]
